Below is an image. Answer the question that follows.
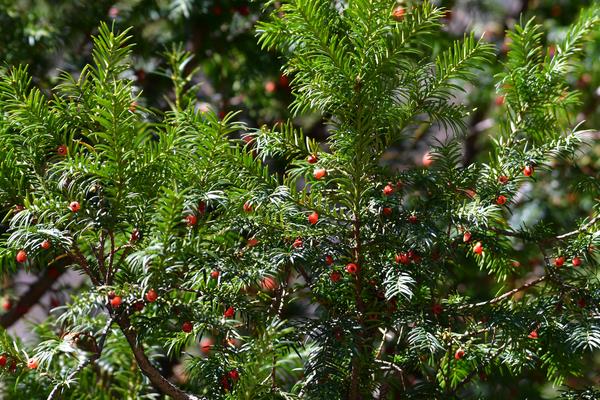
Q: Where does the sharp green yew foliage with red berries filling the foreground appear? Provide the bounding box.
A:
[0,0,600,399]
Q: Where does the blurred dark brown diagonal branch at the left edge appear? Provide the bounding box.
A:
[0,254,73,329]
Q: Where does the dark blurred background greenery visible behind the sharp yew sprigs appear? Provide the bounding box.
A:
[0,0,600,399]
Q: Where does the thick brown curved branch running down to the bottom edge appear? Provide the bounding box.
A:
[117,315,201,400]
